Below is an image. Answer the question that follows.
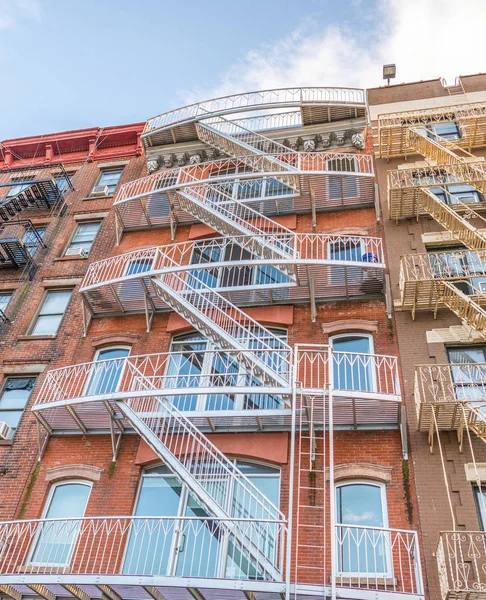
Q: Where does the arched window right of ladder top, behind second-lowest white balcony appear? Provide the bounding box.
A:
[329,334,376,392]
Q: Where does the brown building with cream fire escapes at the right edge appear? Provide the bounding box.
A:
[368,75,486,598]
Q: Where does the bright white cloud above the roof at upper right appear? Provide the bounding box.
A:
[185,0,486,102]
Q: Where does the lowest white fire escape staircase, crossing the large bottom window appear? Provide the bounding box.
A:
[117,384,286,581]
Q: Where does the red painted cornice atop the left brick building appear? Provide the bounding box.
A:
[0,123,145,169]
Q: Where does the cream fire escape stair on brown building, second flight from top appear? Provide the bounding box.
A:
[418,187,486,250]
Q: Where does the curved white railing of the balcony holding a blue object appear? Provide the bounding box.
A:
[81,233,385,292]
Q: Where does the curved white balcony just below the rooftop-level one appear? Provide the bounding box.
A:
[114,152,374,231]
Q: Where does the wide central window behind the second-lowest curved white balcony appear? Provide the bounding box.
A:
[165,329,287,411]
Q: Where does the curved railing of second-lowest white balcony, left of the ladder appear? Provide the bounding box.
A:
[34,347,290,410]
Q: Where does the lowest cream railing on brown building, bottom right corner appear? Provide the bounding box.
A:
[436,531,486,600]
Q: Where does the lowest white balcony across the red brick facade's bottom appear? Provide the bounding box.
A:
[0,516,423,600]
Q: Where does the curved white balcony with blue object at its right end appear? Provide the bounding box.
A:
[80,233,385,316]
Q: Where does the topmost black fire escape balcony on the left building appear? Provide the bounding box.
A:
[0,163,73,222]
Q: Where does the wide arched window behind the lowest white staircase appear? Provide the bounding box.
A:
[122,460,280,579]
